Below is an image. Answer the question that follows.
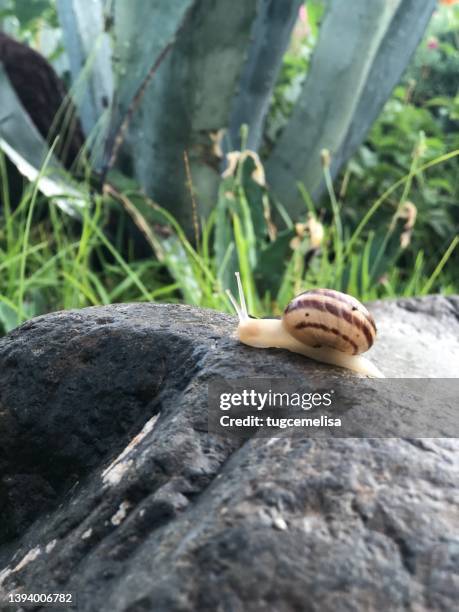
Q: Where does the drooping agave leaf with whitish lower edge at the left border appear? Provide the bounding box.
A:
[0,63,86,215]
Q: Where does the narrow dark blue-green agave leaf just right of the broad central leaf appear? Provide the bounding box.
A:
[227,0,303,151]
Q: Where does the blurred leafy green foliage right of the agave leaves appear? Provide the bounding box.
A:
[341,6,459,280]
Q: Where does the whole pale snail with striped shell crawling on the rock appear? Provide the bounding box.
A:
[227,272,384,378]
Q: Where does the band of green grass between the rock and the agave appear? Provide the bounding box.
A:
[0,143,459,332]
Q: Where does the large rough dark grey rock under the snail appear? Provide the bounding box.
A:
[0,297,459,612]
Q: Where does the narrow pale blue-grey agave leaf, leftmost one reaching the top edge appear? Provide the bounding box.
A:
[57,0,113,135]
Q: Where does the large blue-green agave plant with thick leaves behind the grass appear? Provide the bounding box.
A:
[0,0,436,227]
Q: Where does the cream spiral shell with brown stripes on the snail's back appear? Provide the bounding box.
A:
[283,289,376,355]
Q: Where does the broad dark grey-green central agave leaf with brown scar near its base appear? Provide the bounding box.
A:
[130,0,258,229]
